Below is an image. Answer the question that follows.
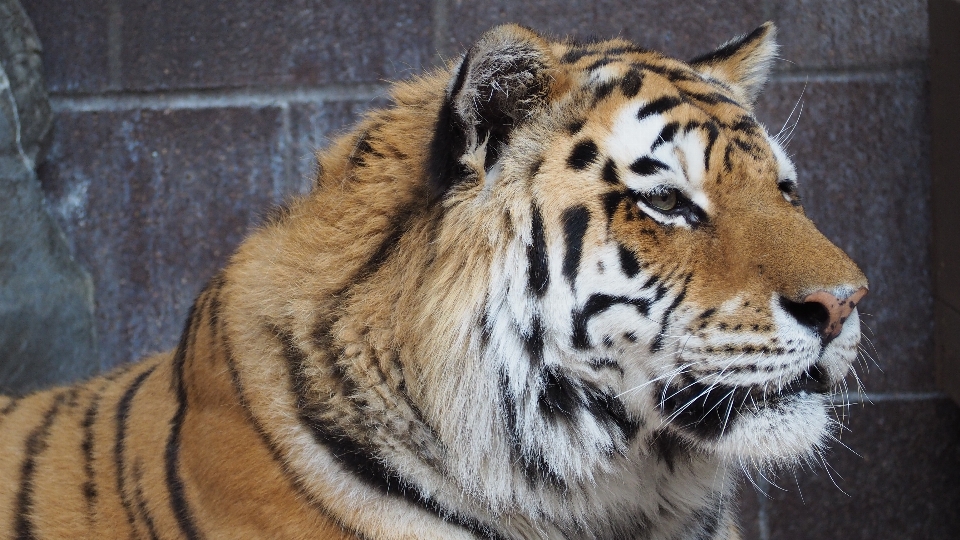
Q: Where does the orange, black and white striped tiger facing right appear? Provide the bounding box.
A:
[0,23,868,540]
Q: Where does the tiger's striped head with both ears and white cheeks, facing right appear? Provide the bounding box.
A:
[412,25,867,486]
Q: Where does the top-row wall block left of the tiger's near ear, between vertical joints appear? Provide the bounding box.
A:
[120,0,432,90]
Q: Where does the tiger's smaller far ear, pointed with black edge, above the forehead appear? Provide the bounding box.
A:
[690,22,779,107]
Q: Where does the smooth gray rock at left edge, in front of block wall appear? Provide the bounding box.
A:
[0,1,99,392]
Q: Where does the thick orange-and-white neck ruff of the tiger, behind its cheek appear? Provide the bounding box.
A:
[216,71,734,538]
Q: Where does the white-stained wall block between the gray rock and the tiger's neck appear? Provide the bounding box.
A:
[40,107,294,367]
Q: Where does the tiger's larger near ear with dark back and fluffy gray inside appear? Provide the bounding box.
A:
[428,25,551,196]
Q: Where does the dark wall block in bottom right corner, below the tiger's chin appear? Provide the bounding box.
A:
[768,399,960,540]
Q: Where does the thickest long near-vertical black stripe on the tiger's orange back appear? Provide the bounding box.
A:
[164,293,209,540]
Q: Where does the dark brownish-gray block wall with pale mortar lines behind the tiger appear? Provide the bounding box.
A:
[7,0,960,540]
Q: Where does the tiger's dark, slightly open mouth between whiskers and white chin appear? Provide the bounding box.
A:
[657,365,832,439]
